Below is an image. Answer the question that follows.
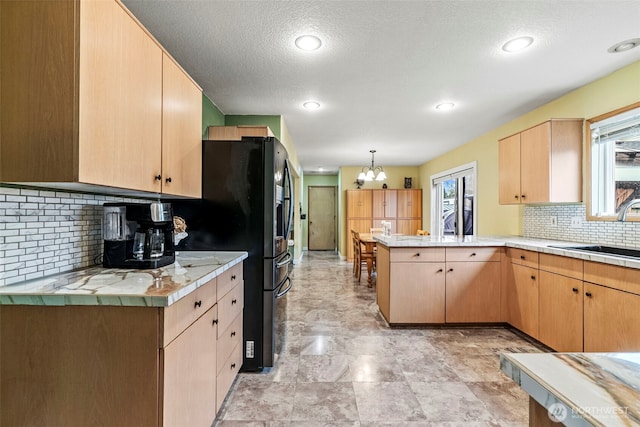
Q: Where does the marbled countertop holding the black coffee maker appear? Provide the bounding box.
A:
[0,251,248,307]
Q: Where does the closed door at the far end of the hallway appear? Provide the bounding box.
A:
[308,186,338,251]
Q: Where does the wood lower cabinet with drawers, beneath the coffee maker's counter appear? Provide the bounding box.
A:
[0,264,244,427]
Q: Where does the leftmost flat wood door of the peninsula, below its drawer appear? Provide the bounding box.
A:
[389,263,445,323]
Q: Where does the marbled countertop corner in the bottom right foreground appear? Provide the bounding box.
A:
[500,353,640,426]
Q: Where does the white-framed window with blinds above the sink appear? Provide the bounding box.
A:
[587,104,640,219]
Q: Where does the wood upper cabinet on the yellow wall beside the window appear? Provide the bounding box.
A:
[498,119,583,204]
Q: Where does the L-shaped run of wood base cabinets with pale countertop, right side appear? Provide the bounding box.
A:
[376,235,640,352]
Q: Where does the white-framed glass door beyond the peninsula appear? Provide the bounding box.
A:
[431,162,476,236]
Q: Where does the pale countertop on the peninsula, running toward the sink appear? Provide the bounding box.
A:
[374,234,640,269]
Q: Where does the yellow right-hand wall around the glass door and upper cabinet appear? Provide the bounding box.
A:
[420,61,640,235]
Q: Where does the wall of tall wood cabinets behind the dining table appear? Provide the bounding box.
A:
[346,189,422,259]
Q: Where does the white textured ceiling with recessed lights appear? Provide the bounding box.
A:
[124,0,640,172]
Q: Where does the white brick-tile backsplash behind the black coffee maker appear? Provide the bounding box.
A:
[0,185,148,286]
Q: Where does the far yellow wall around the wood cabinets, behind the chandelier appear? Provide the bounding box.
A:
[338,166,424,257]
